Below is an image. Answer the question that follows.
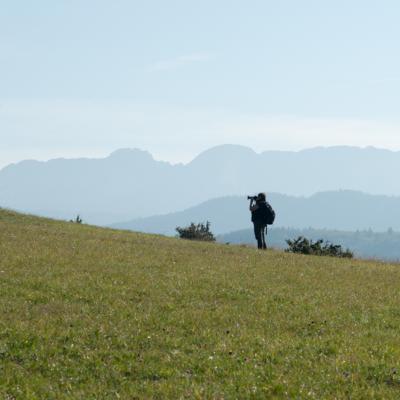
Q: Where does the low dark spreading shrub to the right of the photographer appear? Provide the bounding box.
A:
[286,236,353,258]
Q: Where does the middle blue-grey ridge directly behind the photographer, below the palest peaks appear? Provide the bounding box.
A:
[112,191,400,235]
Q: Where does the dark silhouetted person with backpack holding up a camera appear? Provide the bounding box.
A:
[249,193,275,250]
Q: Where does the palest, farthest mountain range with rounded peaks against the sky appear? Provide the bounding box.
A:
[0,145,400,224]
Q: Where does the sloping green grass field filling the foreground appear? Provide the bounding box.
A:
[0,210,400,400]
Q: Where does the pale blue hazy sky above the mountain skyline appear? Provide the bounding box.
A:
[0,0,400,167]
